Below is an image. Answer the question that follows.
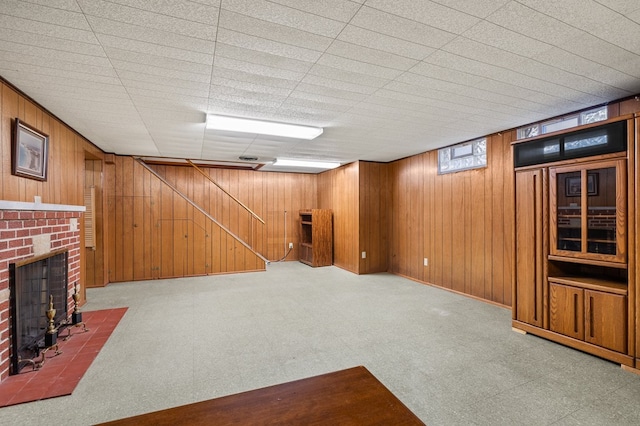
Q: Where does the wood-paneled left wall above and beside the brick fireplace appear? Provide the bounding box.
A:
[0,79,103,301]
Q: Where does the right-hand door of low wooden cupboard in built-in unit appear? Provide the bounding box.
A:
[584,290,627,353]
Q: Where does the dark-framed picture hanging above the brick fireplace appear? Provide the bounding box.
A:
[11,118,49,180]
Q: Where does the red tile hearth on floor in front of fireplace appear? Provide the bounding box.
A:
[0,308,127,407]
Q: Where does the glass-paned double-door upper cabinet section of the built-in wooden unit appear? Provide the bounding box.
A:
[549,159,627,264]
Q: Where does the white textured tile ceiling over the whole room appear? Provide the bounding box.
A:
[0,0,640,170]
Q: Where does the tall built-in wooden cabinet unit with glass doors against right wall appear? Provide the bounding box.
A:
[512,115,638,368]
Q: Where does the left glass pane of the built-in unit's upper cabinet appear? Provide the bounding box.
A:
[556,170,582,252]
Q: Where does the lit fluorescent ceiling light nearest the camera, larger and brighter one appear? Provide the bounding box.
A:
[207,114,323,139]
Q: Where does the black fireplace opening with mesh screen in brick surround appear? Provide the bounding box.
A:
[9,250,68,374]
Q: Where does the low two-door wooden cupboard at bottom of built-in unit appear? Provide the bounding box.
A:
[549,277,627,353]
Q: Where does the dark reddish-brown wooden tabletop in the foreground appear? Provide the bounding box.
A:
[102,367,424,426]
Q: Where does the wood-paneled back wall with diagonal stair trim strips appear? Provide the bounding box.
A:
[106,156,317,282]
